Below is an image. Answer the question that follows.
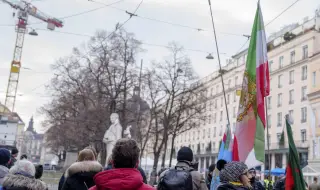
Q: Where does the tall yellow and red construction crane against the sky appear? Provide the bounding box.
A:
[0,0,63,112]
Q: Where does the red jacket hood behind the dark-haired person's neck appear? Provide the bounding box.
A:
[94,168,143,190]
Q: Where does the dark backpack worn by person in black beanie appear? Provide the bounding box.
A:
[158,167,193,190]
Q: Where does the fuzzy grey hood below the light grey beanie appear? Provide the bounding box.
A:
[2,174,47,190]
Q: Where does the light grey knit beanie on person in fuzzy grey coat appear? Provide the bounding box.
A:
[9,160,36,177]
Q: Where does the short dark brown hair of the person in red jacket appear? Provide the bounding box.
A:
[112,138,140,168]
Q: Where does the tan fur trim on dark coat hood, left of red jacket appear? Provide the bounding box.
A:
[65,161,103,178]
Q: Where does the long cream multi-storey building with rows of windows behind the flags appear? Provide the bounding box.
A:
[175,14,320,172]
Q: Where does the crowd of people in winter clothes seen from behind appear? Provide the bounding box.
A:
[0,139,320,190]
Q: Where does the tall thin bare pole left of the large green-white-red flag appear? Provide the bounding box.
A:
[208,0,230,128]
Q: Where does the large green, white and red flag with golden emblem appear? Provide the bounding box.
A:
[231,3,270,168]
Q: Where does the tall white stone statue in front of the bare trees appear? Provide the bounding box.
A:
[103,113,122,165]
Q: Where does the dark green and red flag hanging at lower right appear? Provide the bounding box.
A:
[285,115,306,190]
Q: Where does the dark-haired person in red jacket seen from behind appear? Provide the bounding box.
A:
[90,139,154,190]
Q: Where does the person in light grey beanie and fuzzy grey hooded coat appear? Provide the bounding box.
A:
[2,160,48,190]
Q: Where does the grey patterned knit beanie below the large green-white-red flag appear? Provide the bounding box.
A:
[220,162,248,182]
